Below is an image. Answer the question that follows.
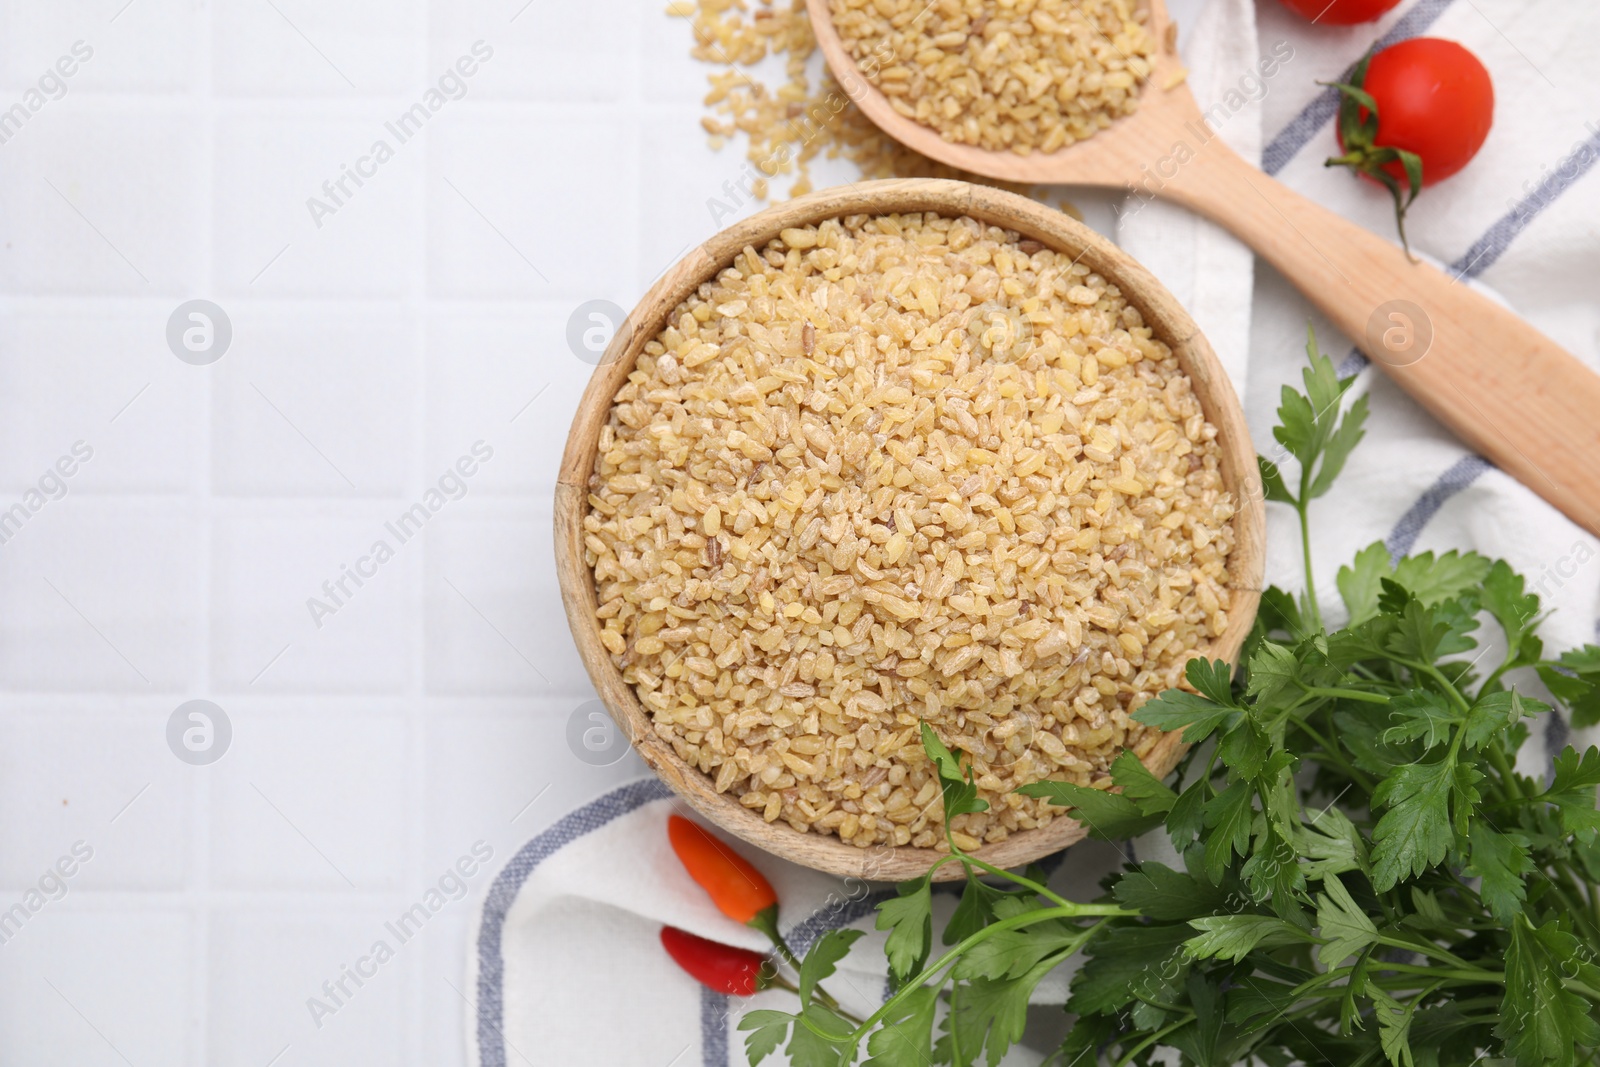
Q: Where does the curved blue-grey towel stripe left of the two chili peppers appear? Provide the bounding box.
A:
[478,777,675,1067]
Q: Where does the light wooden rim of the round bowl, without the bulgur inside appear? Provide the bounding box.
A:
[555,179,1266,880]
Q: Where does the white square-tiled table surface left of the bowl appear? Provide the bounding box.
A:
[0,0,1192,1067]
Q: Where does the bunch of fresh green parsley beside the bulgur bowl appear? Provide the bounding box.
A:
[741,329,1600,1067]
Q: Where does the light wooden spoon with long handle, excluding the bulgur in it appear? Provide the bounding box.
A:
[808,0,1600,534]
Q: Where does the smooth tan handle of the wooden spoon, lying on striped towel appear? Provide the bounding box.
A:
[1158,138,1600,534]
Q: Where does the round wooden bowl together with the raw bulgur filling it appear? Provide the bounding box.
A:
[557,181,1261,878]
